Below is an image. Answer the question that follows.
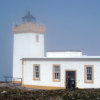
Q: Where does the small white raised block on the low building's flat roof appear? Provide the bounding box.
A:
[46,51,82,57]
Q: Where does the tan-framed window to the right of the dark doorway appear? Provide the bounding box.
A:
[85,65,93,83]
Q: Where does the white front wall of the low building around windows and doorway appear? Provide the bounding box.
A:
[23,61,100,88]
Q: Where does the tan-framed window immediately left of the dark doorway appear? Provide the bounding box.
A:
[53,65,60,81]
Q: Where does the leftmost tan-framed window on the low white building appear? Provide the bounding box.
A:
[33,64,40,80]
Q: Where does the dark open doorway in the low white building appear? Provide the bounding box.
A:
[65,71,76,88]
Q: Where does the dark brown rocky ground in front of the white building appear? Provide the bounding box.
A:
[0,84,100,100]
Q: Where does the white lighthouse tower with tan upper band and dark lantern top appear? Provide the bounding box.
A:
[12,12,45,82]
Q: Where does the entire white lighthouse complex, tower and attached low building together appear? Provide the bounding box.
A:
[13,14,100,89]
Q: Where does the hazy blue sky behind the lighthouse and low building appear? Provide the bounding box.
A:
[0,0,100,79]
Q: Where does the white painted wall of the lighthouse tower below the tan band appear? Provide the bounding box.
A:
[13,33,44,78]
